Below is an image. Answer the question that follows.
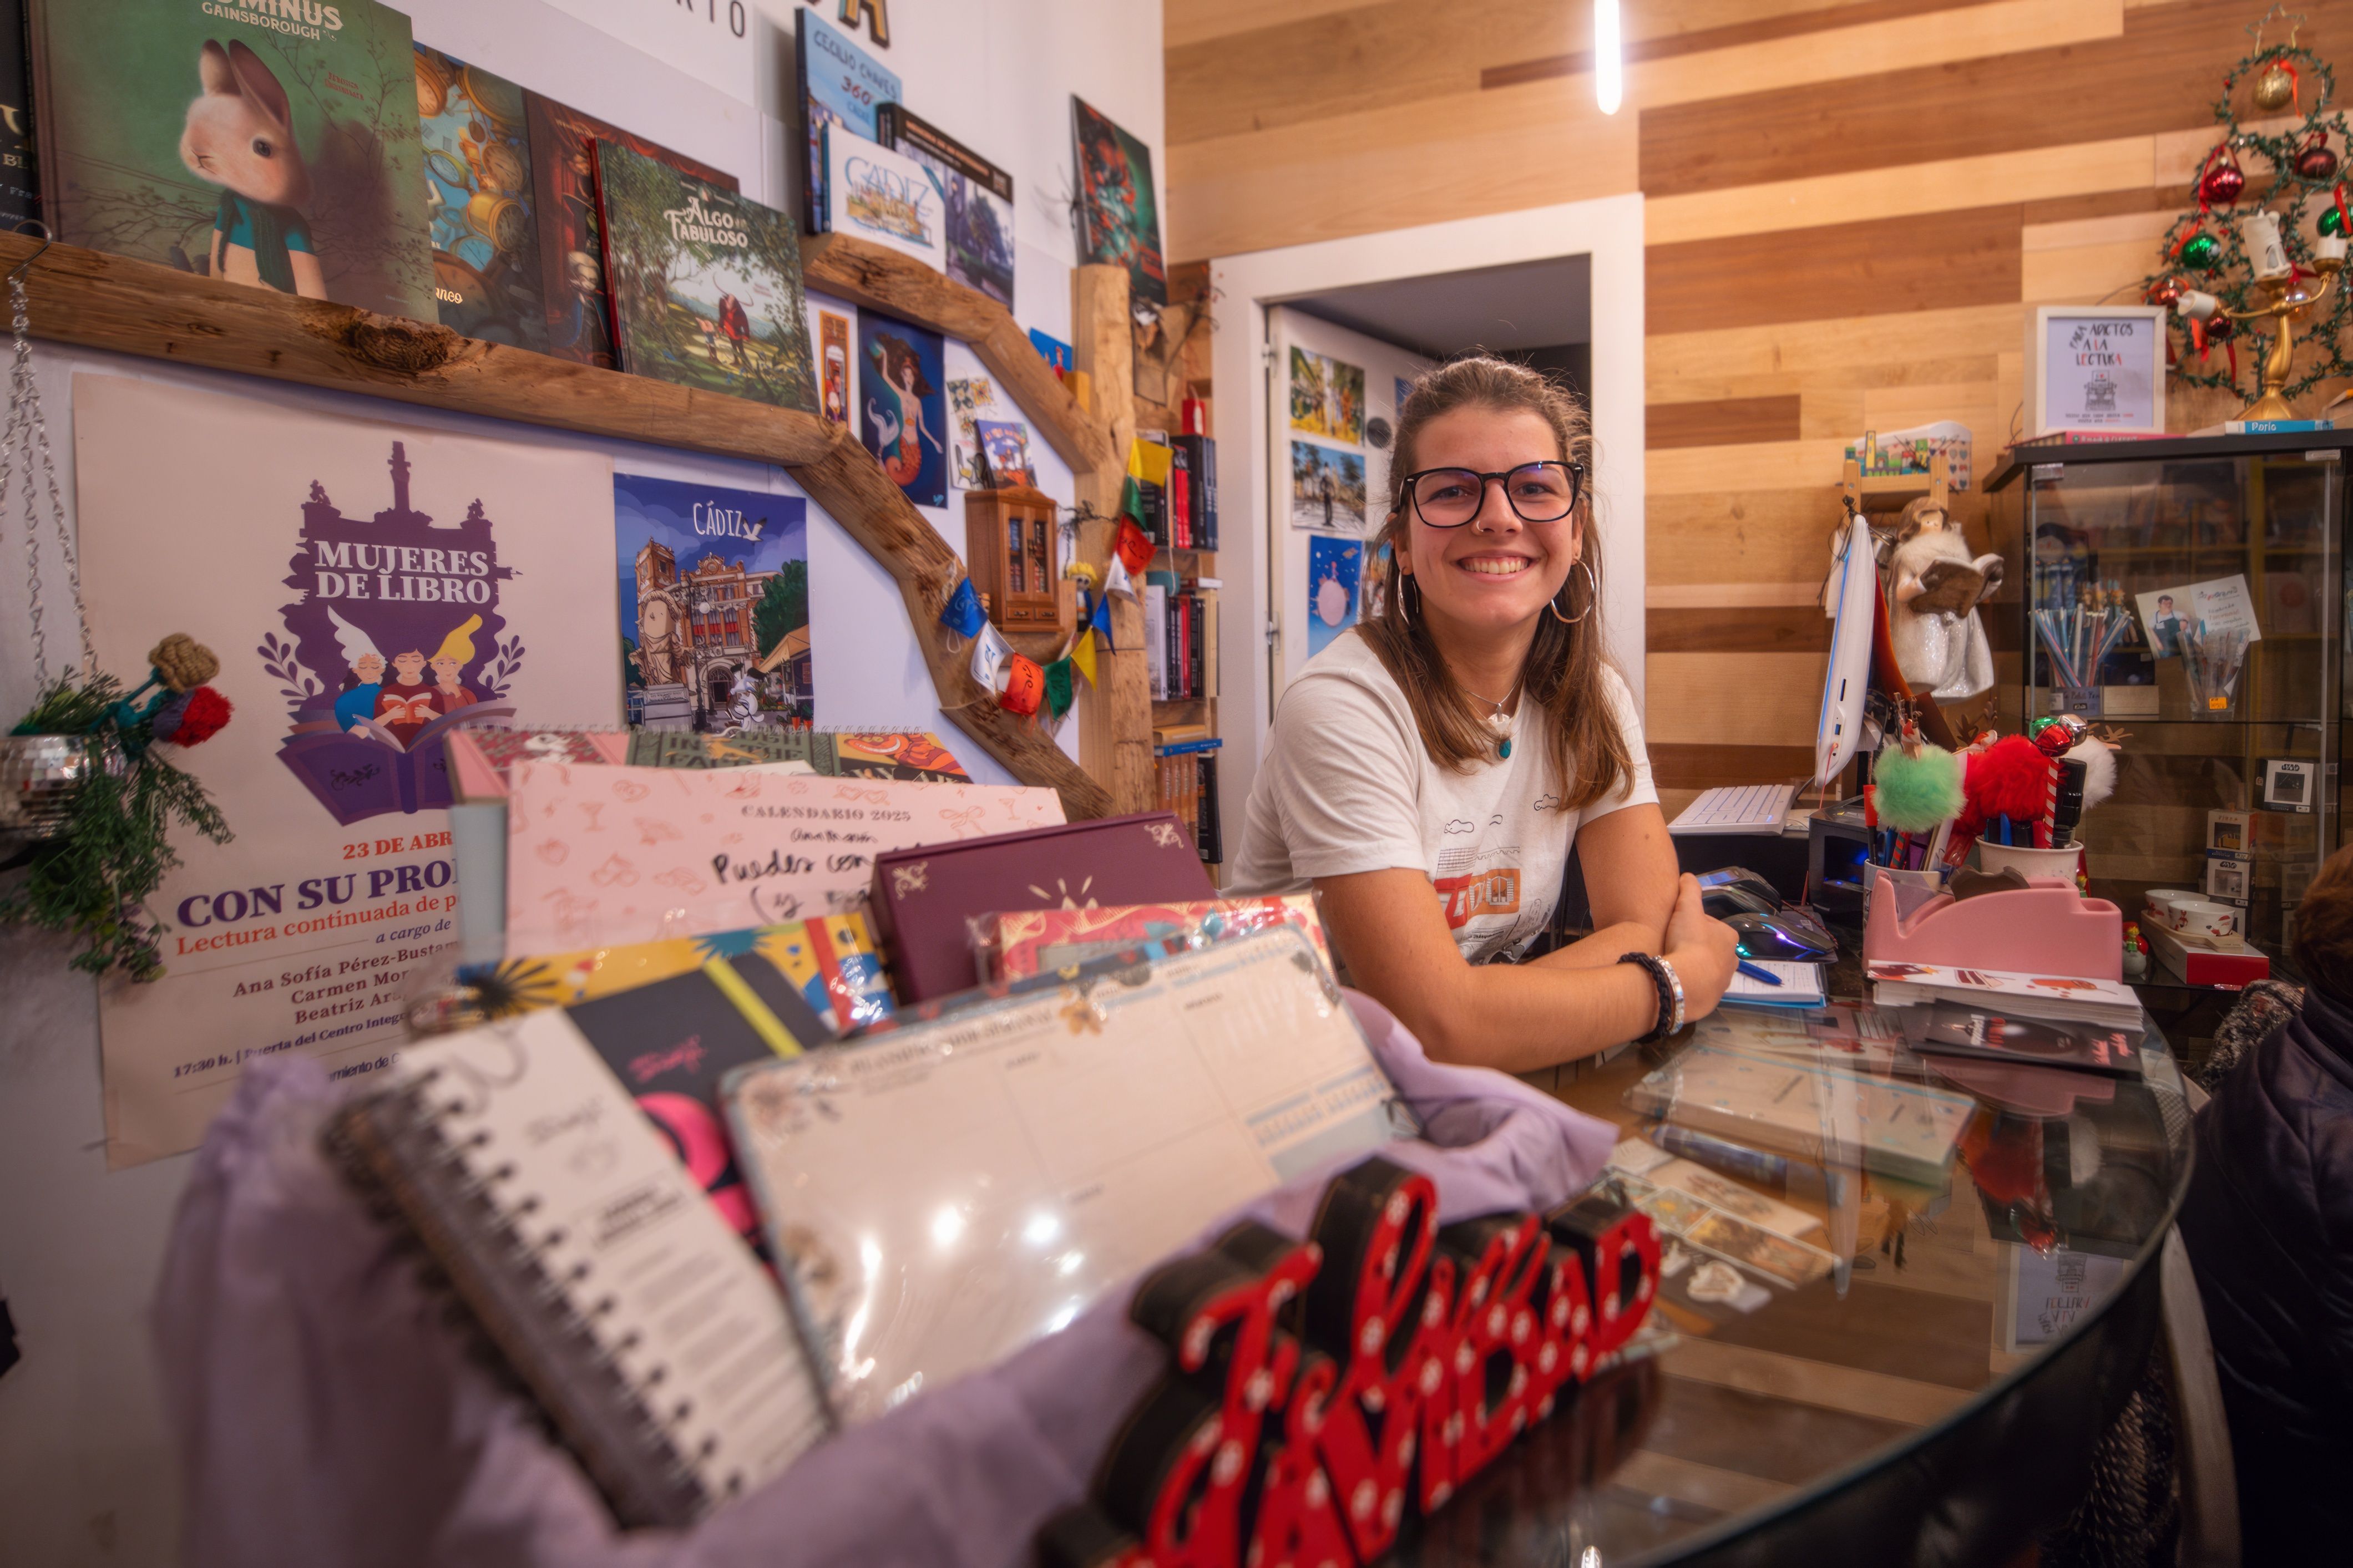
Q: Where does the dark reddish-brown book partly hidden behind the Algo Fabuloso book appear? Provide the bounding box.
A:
[523,89,736,369]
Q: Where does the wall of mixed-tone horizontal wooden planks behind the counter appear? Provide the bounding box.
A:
[1162,0,2353,811]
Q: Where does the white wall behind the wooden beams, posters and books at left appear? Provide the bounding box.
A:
[0,0,1162,1568]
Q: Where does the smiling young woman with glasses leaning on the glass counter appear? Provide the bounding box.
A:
[1236,357,1737,1069]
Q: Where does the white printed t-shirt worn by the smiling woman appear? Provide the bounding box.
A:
[1228,637,1659,964]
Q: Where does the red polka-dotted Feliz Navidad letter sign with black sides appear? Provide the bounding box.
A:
[1038,1159,1659,1568]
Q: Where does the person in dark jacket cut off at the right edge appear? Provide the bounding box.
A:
[2181,846,2353,1566]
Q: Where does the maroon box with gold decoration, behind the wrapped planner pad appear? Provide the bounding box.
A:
[871,811,1217,1002]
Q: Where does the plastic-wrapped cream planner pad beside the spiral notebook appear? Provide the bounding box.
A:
[727,928,1409,1424]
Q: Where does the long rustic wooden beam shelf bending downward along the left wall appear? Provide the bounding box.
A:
[0,235,1115,818]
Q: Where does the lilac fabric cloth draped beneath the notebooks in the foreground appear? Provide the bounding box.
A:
[155,992,1617,1568]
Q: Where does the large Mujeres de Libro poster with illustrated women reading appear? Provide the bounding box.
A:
[73,374,621,1168]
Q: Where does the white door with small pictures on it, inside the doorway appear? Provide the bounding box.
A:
[1266,306,1433,698]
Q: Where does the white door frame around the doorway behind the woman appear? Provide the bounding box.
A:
[1210,193,1644,823]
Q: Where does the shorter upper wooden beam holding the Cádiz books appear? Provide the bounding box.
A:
[800,235,1127,473]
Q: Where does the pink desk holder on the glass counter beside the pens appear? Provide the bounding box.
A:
[1864,865,2125,980]
